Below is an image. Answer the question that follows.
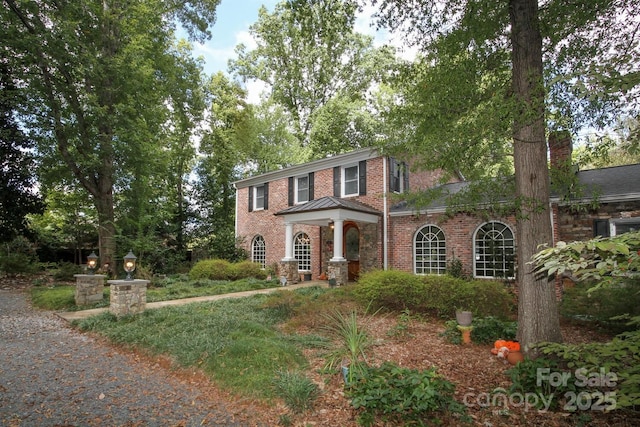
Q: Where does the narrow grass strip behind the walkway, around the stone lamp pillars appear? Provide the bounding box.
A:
[30,275,280,311]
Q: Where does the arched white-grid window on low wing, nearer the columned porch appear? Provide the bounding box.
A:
[413,225,447,274]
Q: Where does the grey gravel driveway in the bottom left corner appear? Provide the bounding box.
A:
[0,290,268,427]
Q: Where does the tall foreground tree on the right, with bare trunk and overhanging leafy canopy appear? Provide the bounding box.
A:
[374,0,639,349]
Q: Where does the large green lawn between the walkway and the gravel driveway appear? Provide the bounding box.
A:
[77,290,330,399]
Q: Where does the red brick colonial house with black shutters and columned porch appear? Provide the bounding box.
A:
[235,138,640,284]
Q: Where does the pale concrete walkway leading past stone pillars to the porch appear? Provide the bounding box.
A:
[56,281,329,322]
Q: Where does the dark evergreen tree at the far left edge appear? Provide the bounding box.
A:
[0,62,43,242]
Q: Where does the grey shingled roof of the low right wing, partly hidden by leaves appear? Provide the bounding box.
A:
[390,163,640,216]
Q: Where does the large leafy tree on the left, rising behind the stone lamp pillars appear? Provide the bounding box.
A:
[0,0,219,271]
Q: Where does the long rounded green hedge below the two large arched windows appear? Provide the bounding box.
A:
[354,270,514,318]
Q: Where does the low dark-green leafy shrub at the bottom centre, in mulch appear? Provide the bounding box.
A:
[347,362,466,426]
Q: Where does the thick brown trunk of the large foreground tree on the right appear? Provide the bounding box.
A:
[509,0,562,356]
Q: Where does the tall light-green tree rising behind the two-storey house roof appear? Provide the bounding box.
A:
[230,0,395,157]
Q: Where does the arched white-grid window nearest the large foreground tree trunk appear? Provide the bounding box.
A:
[473,221,516,278]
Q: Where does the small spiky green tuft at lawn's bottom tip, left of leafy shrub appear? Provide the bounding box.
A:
[273,370,320,414]
